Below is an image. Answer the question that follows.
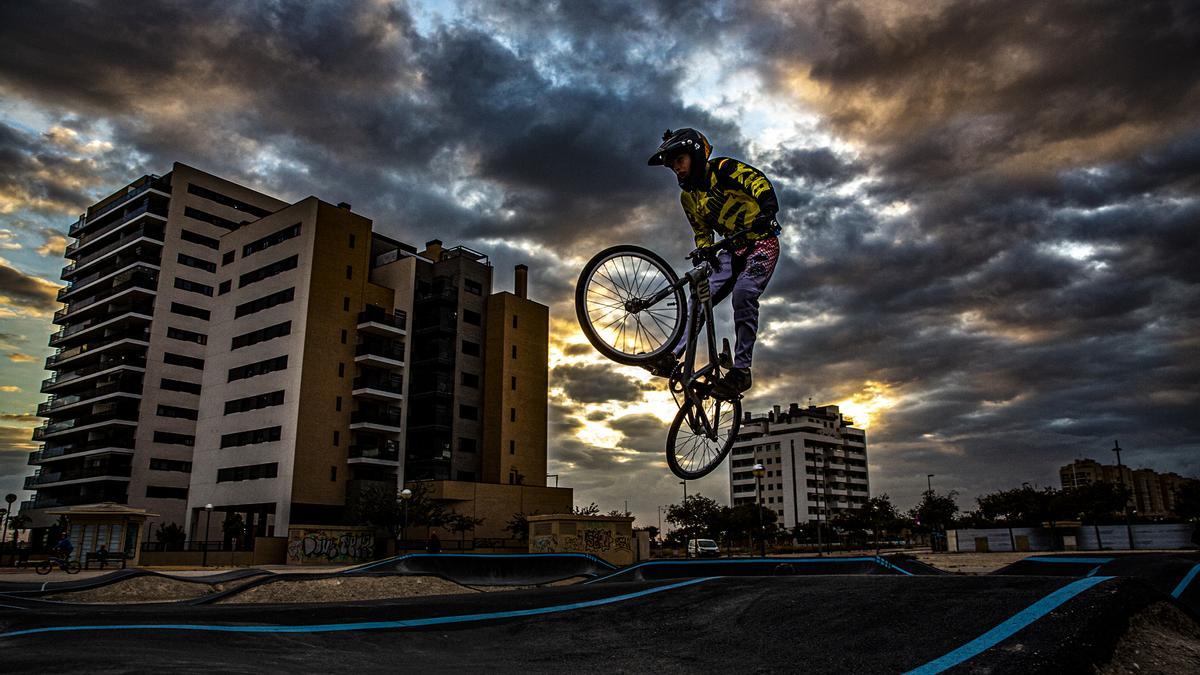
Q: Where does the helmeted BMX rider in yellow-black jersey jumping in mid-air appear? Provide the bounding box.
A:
[647,129,780,398]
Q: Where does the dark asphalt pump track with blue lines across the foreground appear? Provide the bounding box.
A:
[0,551,1200,674]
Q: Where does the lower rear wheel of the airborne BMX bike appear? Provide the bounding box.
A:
[667,396,742,480]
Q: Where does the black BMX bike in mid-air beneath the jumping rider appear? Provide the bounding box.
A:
[575,231,746,480]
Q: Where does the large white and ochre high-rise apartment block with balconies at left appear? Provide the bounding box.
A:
[23,163,570,547]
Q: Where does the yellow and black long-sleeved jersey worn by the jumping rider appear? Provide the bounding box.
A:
[679,157,779,246]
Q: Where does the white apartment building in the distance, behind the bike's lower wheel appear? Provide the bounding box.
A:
[730,404,870,528]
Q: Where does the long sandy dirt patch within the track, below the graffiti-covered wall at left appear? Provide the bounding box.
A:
[217,569,479,604]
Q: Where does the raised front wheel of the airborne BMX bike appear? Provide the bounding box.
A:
[575,245,688,365]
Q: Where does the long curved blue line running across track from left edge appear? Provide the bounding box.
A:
[0,577,716,639]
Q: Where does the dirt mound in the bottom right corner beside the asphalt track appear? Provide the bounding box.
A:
[1097,602,1200,675]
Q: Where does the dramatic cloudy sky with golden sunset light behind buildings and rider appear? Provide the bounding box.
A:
[0,0,1200,522]
